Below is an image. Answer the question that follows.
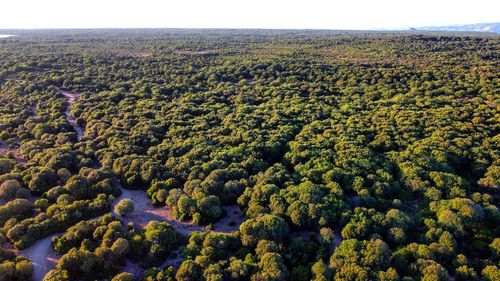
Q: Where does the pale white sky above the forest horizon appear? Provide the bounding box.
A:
[0,0,500,29]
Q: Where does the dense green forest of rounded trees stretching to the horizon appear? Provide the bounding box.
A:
[0,29,500,281]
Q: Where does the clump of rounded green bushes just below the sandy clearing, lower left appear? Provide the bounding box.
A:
[48,214,182,280]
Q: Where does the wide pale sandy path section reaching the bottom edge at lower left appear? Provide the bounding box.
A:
[18,235,61,281]
